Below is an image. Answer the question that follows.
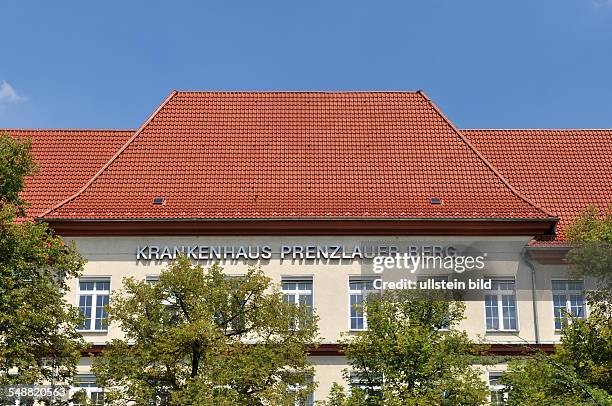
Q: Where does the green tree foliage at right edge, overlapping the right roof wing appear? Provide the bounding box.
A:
[501,207,612,405]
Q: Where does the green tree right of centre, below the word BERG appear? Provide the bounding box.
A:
[328,290,488,406]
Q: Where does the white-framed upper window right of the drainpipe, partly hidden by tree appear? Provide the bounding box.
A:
[552,281,586,330]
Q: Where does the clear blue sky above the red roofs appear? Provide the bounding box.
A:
[0,0,612,128]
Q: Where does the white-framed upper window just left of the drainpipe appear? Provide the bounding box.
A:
[485,280,518,331]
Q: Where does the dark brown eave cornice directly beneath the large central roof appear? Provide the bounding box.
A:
[39,218,557,239]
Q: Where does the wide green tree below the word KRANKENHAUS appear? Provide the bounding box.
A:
[94,256,317,405]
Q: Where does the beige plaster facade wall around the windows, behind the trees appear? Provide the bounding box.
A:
[68,236,584,399]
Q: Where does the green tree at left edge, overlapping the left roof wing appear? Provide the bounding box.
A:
[0,135,84,400]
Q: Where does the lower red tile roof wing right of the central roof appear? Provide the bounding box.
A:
[462,130,612,243]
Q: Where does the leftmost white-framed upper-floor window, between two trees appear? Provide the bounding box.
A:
[78,278,110,331]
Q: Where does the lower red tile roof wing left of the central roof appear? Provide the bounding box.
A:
[0,129,134,217]
